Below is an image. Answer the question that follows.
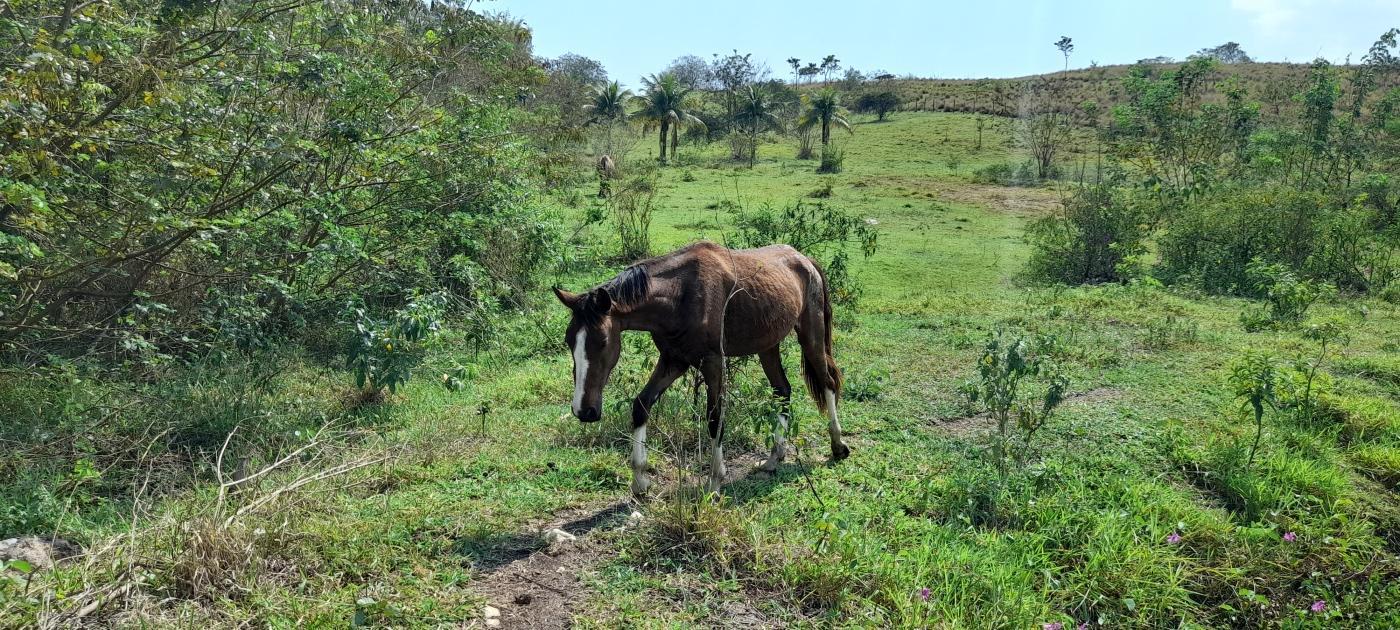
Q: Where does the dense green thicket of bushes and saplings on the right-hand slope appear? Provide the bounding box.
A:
[1030,32,1400,295]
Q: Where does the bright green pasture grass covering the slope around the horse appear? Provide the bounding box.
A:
[0,113,1400,627]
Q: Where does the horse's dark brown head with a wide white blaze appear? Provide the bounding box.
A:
[554,287,622,423]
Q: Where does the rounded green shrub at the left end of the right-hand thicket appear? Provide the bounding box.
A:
[1026,185,1149,284]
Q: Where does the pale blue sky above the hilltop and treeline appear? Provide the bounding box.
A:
[472,0,1400,87]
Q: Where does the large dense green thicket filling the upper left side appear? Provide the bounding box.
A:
[0,0,559,363]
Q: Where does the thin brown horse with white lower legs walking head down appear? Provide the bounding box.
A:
[554,242,850,496]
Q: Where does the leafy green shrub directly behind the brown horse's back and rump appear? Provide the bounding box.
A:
[729,202,879,304]
